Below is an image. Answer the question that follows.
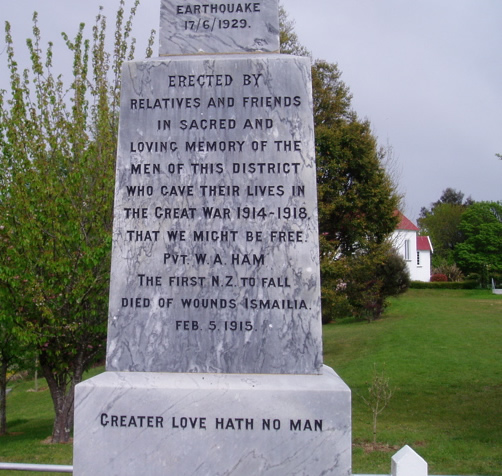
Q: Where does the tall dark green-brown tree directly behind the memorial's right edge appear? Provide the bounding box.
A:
[281,10,400,322]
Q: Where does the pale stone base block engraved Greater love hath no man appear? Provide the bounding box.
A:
[73,367,351,476]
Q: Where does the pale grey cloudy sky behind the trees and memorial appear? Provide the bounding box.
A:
[0,0,502,220]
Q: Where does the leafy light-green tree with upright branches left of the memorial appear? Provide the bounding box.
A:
[0,0,151,442]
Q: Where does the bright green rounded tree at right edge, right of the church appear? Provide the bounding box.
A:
[455,202,502,284]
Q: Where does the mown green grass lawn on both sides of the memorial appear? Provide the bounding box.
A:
[0,290,502,476]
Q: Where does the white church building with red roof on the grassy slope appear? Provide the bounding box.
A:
[392,212,434,282]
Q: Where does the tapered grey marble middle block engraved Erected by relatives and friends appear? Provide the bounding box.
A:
[107,54,322,374]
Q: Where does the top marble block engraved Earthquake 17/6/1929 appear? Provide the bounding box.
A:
[159,0,280,56]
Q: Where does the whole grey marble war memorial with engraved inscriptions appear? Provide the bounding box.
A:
[73,0,351,476]
